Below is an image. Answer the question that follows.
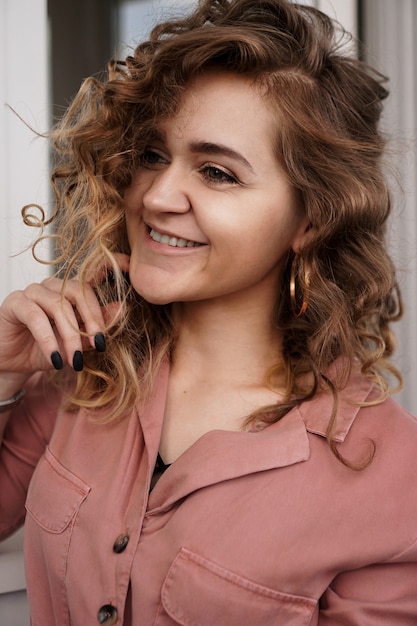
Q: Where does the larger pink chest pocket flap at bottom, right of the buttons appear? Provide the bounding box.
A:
[155,548,317,626]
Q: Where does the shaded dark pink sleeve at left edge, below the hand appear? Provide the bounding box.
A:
[0,374,60,540]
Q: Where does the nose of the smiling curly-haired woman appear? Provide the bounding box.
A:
[143,164,191,213]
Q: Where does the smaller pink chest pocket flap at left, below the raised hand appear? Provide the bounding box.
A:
[26,448,90,534]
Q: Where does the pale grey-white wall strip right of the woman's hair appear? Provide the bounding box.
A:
[364,0,417,415]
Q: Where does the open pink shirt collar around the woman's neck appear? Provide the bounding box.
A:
[139,360,372,508]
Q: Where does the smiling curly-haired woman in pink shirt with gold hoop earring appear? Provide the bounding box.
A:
[0,0,417,626]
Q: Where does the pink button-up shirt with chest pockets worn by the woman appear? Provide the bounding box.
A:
[0,364,417,626]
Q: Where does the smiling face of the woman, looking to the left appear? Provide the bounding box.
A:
[125,73,307,304]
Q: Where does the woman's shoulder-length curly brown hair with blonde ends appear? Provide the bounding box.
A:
[25,0,401,453]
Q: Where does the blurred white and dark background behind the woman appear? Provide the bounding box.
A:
[0,0,417,626]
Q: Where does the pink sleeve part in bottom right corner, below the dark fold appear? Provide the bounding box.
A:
[319,542,417,626]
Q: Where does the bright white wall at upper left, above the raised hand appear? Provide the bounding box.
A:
[0,0,48,300]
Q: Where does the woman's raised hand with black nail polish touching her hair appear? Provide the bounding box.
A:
[0,255,128,386]
